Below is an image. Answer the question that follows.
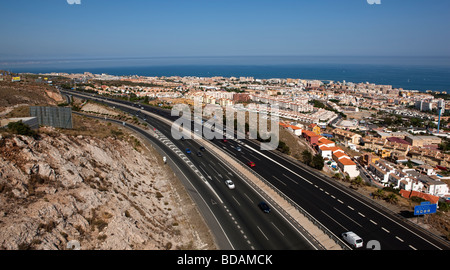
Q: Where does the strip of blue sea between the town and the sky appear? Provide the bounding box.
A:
[0,56,450,93]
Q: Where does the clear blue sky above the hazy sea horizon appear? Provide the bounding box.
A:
[0,0,450,60]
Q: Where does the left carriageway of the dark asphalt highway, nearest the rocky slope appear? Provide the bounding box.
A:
[66,90,317,250]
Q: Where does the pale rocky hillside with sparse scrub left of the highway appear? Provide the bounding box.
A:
[0,128,215,250]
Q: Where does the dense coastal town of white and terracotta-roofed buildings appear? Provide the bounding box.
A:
[49,73,450,196]
